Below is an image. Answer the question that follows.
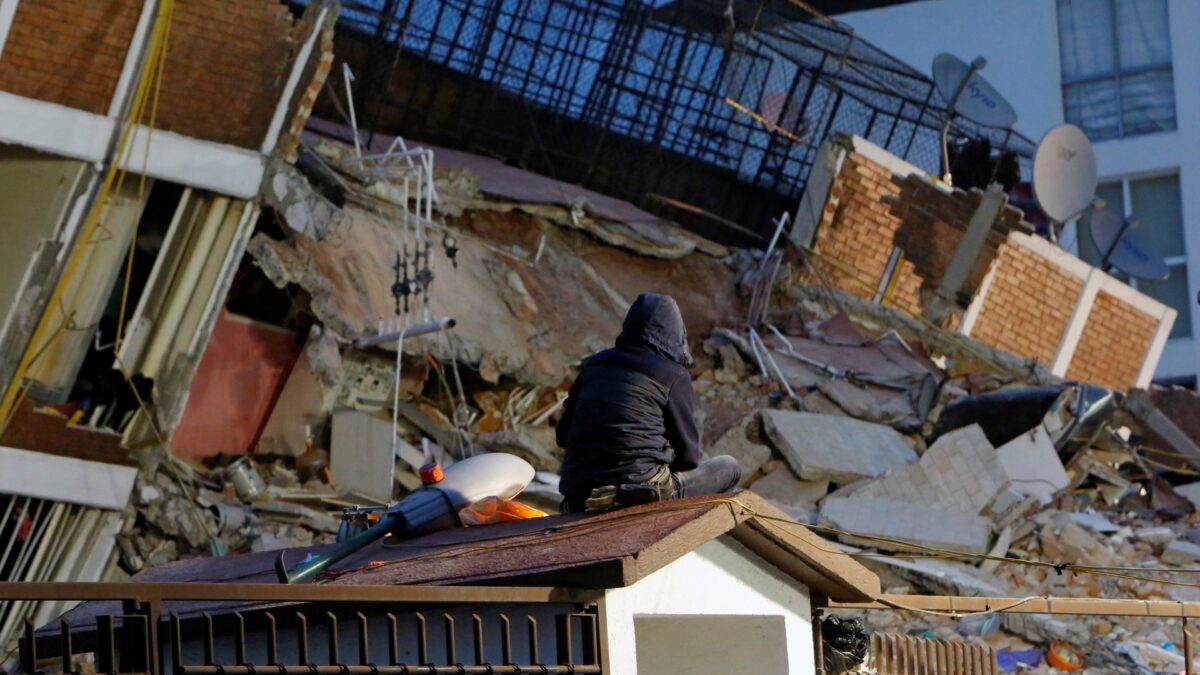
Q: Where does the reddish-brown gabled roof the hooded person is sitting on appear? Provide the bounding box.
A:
[56,491,881,626]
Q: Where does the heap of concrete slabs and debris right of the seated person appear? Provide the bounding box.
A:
[696,289,1200,671]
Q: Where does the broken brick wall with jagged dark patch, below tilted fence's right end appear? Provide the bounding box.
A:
[806,146,1028,313]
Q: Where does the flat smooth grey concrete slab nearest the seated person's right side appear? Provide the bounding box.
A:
[762,410,917,484]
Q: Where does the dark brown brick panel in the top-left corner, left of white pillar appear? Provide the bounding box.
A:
[0,0,142,114]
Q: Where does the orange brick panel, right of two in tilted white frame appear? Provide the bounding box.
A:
[1067,291,1158,389]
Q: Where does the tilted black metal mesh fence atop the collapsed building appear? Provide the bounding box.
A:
[314,0,1034,239]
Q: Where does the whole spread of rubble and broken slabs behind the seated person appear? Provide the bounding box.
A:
[108,127,1200,668]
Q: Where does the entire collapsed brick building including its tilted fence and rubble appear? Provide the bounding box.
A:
[0,0,1200,669]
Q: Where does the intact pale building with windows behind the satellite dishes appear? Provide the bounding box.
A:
[840,0,1200,387]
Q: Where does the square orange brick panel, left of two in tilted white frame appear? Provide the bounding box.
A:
[971,236,1084,364]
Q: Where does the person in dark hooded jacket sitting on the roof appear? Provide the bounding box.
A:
[554,293,742,513]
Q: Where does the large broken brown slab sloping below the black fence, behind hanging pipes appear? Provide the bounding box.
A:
[248,121,742,384]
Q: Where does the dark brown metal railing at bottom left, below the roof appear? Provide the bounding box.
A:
[0,583,601,675]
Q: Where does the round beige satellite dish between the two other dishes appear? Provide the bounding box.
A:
[1033,124,1096,225]
